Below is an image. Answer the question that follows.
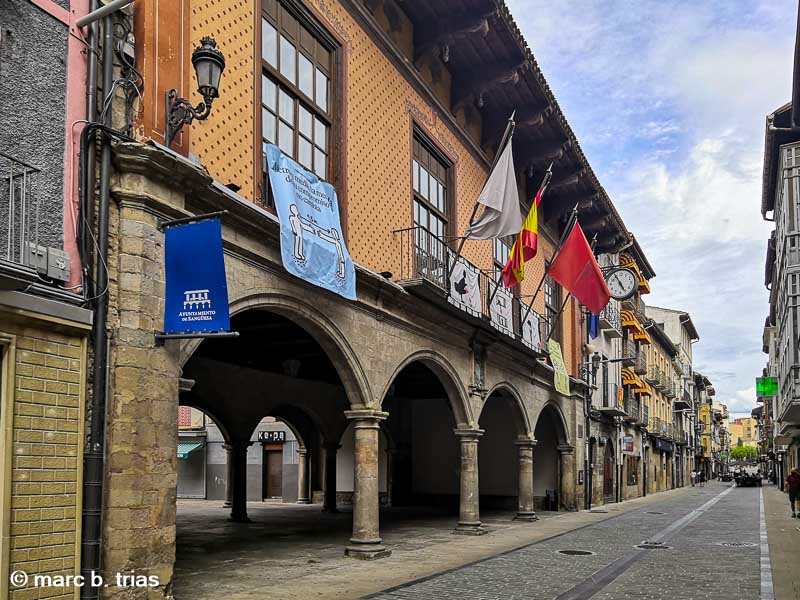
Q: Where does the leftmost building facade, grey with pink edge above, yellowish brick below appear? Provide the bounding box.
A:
[0,1,93,598]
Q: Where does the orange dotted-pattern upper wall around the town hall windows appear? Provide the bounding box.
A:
[184,0,577,373]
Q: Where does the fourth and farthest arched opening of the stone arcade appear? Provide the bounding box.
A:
[533,402,570,510]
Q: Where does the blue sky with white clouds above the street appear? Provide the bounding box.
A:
[506,0,797,413]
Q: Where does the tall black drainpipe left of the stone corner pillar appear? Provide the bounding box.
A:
[81,15,114,600]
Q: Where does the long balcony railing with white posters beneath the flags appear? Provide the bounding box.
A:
[394,227,550,352]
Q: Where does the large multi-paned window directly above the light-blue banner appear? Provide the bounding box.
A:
[261,0,335,200]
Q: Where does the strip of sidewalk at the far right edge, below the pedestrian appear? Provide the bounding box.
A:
[764,485,800,600]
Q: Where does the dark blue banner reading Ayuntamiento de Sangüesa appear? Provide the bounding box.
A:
[164,219,231,333]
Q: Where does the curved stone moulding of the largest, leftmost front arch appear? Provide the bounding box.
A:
[178,291,374,409]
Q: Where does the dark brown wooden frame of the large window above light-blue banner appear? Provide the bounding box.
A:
[254,0,347,216]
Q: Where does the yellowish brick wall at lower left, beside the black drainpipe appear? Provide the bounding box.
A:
[0,315,86,599]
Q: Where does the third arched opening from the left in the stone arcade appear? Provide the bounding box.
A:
[478,384,532,510]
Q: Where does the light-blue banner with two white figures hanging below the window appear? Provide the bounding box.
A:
[267,144,356,300]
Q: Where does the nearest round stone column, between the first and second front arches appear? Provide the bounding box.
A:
[345,410,391,560]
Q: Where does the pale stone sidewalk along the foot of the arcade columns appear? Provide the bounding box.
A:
[174,487,696,600]
